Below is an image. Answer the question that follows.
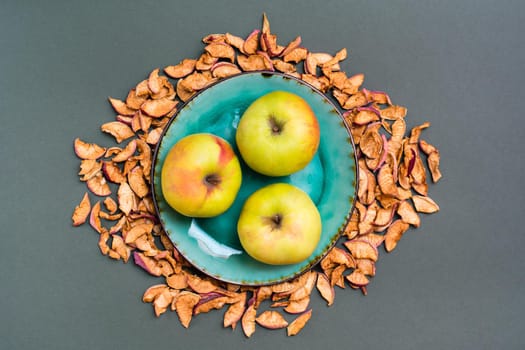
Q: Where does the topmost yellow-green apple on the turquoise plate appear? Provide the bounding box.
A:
[235,91,320,176]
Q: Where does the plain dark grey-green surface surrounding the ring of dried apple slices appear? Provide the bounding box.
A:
[0,0,525,349]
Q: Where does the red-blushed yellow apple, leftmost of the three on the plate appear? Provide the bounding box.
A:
[161,133,242,218]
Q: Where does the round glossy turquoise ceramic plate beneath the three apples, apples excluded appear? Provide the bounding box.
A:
[152,72,357,285]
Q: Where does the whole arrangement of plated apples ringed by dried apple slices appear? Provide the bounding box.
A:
[72,15,441,337]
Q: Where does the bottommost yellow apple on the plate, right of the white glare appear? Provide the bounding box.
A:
[237,183,322,265]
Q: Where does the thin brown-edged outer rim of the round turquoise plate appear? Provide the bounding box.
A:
[150,70,359,287]
